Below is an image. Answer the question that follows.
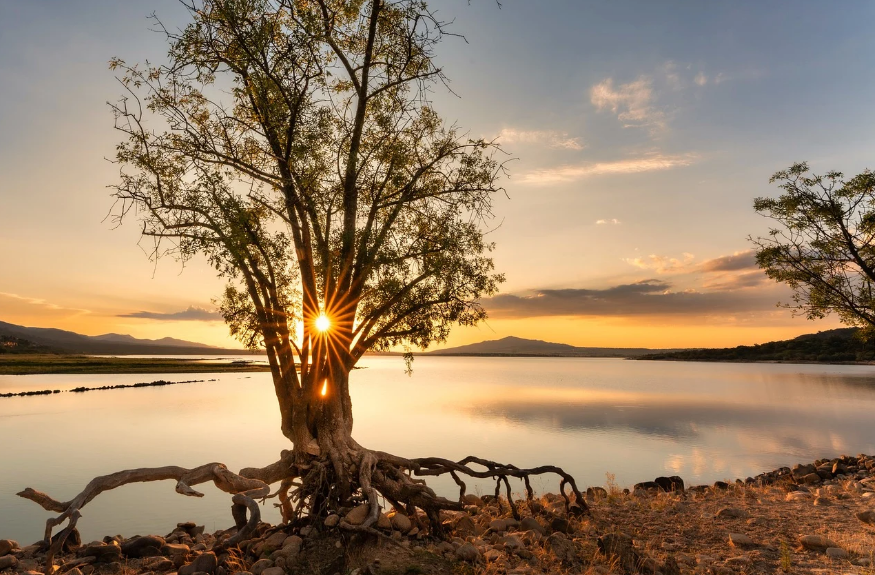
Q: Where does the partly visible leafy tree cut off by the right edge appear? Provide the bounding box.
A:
[751,163,875,332]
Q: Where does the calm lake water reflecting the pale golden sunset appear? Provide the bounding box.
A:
[0,357,875,543]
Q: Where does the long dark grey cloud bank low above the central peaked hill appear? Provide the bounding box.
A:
[483,279,775,318]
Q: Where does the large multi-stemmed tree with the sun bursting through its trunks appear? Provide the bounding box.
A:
[18,0,585,560]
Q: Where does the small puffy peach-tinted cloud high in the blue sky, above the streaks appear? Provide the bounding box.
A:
[589,76,666,131]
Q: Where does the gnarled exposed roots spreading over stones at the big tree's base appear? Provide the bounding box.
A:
[18,446,588,575]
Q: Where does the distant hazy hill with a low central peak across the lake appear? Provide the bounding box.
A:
[426,336,674,357]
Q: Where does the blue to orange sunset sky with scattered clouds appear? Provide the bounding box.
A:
[0,0,875,348]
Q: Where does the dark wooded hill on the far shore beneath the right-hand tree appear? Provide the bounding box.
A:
[638,327,875,363]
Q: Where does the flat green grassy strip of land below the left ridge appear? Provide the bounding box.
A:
[0,354,269,375]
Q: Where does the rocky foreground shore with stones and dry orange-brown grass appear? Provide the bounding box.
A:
[0,455,875,575]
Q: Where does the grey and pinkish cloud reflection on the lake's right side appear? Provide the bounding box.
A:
[466,395,875,476]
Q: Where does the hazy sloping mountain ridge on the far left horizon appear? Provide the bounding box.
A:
[0,321,249,355]
